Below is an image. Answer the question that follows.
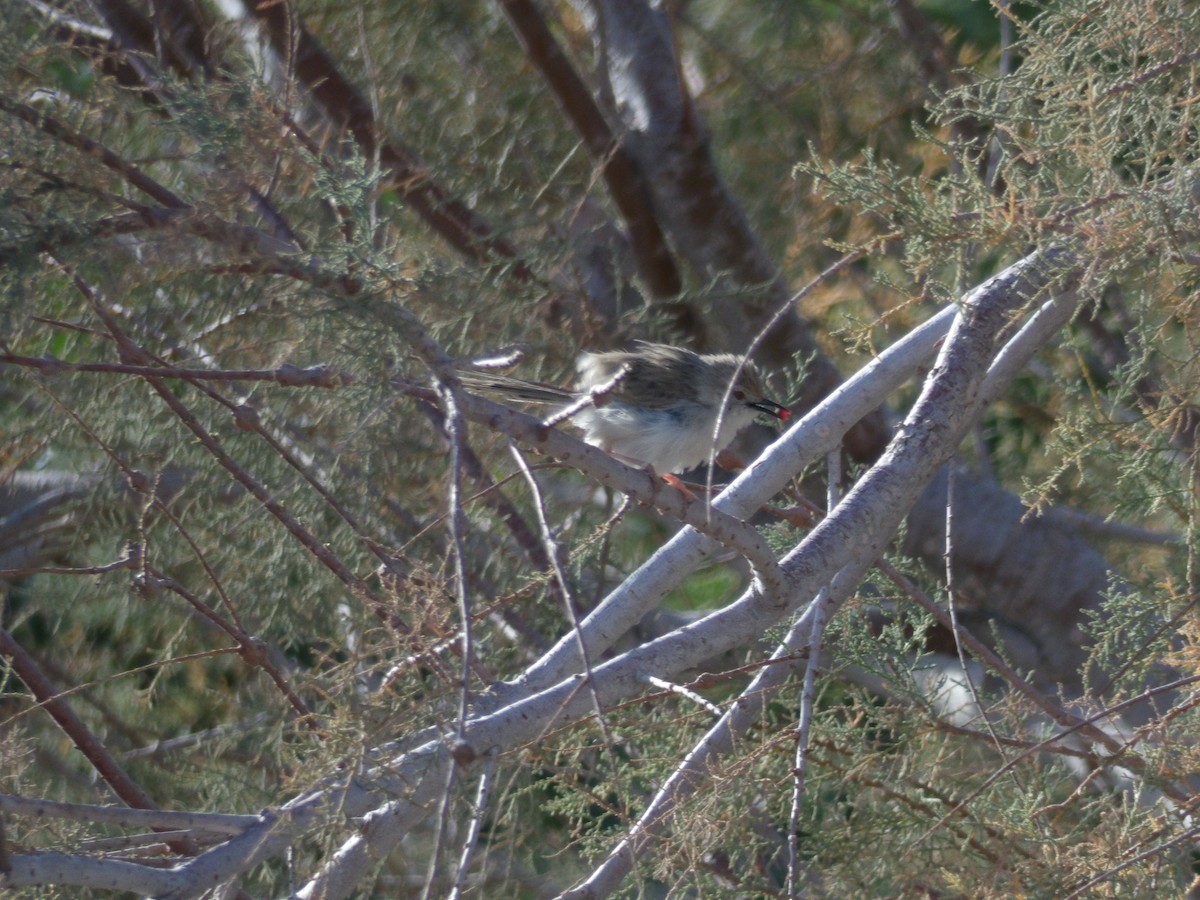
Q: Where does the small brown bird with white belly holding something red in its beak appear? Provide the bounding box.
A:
[461,342,792,474]
